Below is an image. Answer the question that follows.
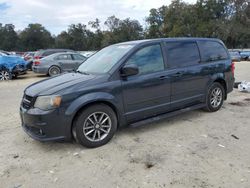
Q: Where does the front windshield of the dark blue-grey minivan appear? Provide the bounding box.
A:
[77,44,134,74]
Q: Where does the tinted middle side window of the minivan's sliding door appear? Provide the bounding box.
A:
[166,42,200,68]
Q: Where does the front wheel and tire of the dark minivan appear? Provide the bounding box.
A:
[72,104,117,148]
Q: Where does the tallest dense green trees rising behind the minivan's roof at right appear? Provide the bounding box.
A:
[146,0,250,48]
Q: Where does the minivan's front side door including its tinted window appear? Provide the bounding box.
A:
[122,43,170,123]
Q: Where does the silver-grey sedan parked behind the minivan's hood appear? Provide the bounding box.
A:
[32,52,87,76]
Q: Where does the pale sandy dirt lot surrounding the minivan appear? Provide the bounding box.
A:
[0,62,250,188]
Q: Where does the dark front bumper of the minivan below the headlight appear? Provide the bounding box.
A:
[20,106,71,141]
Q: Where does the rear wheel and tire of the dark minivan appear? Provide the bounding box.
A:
[204,82,225,112]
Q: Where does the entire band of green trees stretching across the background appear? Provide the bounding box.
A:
[0,0,250,51]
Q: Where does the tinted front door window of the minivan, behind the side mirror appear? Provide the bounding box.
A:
[126,44,164,74]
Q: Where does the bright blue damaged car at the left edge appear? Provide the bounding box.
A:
[0,52,27,80]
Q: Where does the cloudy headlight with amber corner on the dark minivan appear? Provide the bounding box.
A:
[34,95,62,110]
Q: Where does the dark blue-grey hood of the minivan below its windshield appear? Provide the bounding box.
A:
[24,73,96,97]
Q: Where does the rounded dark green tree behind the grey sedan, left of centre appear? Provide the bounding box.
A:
[20,24,54,51]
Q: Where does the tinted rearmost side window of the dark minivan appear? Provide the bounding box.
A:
[198,41,228,62]
